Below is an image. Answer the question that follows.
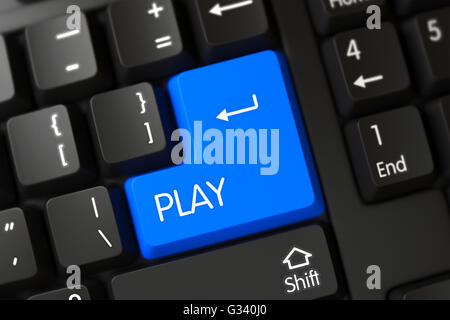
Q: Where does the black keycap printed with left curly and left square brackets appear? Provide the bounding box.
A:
[7,105,92,195]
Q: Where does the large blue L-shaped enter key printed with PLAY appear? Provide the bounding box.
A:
[125,51,324,259]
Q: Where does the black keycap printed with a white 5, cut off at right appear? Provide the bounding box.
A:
[404,3,450,95]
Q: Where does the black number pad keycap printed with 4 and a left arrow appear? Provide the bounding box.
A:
[324,23,411,116]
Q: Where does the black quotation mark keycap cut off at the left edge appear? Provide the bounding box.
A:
[0,208,37,285]
